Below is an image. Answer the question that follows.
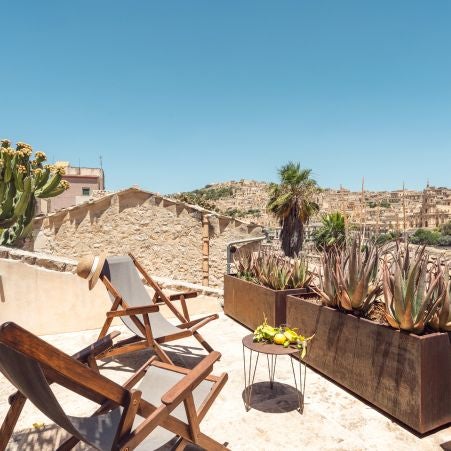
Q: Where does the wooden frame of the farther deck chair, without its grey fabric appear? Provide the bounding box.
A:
[97,253,219,363]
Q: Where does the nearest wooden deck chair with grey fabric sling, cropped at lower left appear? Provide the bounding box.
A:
[0,323,227,451]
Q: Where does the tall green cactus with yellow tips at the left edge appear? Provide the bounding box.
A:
[0,139,69,245]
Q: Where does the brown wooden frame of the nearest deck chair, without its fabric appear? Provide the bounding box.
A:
[0,323,227,451]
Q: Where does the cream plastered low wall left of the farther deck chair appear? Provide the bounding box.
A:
[0,247,111,335]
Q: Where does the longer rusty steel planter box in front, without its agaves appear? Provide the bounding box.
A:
[286,296,451,434]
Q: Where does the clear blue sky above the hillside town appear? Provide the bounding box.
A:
[0,0,451,193]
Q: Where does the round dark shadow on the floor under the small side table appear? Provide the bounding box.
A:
[241,381,301,413]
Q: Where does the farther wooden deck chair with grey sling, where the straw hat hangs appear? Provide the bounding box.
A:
[98,254,218,363]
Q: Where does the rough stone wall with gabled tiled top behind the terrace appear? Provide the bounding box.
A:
[31,188,262,287]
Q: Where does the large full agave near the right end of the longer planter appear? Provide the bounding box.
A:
[382,245,444,334]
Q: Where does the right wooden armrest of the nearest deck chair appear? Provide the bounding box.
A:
[161,351,221,407]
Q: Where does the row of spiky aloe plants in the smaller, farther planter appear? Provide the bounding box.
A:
[234,251,313,290]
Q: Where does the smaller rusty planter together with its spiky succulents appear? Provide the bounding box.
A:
[224,251,312,330]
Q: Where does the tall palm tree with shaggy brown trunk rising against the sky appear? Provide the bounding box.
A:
[267,161,319,257]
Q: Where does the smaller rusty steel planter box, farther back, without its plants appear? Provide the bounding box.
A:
[224,274,309,330]
